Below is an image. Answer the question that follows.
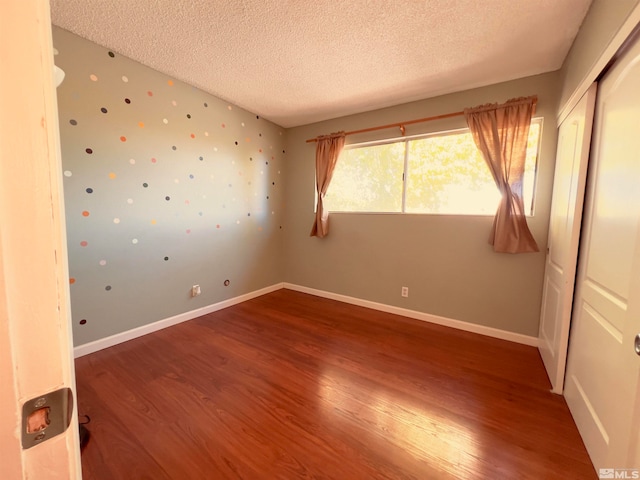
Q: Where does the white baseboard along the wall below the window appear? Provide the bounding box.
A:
[284,282,538,347]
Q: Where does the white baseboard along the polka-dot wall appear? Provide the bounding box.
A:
[73,283,284,358]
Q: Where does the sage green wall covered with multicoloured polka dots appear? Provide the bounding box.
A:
[53,27,285,345]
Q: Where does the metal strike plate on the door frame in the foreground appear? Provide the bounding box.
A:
[22,388,73,450]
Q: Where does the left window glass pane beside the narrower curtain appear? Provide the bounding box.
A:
[324,142,404,212]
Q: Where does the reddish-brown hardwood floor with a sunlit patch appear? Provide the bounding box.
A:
[76,290,597,480]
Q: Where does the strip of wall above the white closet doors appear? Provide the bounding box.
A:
[560,0,640,107]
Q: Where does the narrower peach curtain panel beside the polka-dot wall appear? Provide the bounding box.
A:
[310,132,345,238]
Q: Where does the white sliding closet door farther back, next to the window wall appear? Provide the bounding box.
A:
[538,84,597,393]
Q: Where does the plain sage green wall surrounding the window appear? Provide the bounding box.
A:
[284,72,559,336]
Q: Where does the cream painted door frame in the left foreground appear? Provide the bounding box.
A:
[0,0,81,480]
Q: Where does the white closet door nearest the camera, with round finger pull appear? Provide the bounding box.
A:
[565,34,640,469]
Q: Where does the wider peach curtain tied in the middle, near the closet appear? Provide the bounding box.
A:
[464,96,539,253]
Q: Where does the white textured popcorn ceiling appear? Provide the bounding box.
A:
[51,0,591,127]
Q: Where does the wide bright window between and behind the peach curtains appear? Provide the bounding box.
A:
[324,119,542,215]
